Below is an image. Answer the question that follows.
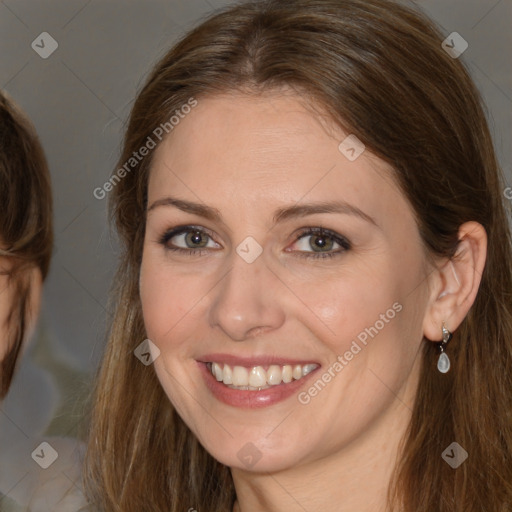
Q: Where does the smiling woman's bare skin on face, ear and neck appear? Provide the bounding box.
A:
[140,91,486,512]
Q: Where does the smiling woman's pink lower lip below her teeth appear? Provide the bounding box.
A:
[198,361,320,409]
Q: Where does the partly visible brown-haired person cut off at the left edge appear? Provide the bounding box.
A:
[0,92,85,512]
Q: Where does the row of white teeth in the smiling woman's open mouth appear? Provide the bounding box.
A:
[206,362,319,391]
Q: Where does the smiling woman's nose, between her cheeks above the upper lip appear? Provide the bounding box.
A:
[209,247,285,341]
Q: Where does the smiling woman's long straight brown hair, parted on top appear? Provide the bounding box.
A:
[85,0,512,512]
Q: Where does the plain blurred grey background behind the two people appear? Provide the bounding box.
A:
[0,0,512,504]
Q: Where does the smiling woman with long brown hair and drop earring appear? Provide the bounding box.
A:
[86,0,512,512]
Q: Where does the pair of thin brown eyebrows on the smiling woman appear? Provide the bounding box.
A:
[147,196,380,229]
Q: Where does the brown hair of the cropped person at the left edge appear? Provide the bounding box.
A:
[0,92,53,399]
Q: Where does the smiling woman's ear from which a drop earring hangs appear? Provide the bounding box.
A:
[423,221,487,341]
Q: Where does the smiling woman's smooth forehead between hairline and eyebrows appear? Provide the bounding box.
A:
[148,93,408,228]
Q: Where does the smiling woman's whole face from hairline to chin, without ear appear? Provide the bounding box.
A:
[140,93,428,471]
